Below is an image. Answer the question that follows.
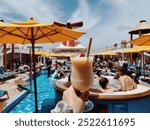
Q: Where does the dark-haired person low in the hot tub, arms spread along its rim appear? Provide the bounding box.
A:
[89,77,119,93]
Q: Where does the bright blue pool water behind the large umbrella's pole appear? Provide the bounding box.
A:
[10,74,55,113]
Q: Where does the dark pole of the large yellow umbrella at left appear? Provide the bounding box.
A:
[31,28,38,113]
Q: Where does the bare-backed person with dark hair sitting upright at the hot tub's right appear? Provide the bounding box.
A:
[117,67,136,91]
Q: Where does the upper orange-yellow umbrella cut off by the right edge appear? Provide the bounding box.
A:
[128,35,150,46]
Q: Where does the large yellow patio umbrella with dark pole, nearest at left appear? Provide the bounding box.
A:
[0,18,85,112]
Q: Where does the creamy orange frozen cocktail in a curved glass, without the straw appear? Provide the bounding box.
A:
[71,57,94,91]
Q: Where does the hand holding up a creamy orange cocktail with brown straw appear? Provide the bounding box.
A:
[63,38,94,112]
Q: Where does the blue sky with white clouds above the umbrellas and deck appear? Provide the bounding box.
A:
[0,0,150,49]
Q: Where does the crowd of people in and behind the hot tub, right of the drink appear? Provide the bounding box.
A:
[93,58,141,92]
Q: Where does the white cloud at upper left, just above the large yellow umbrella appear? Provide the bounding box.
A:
[0,0,62,23]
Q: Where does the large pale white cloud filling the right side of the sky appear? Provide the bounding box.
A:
[78,0,150,49]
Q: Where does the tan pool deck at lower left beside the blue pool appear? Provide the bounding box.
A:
[0,74,29,112]
